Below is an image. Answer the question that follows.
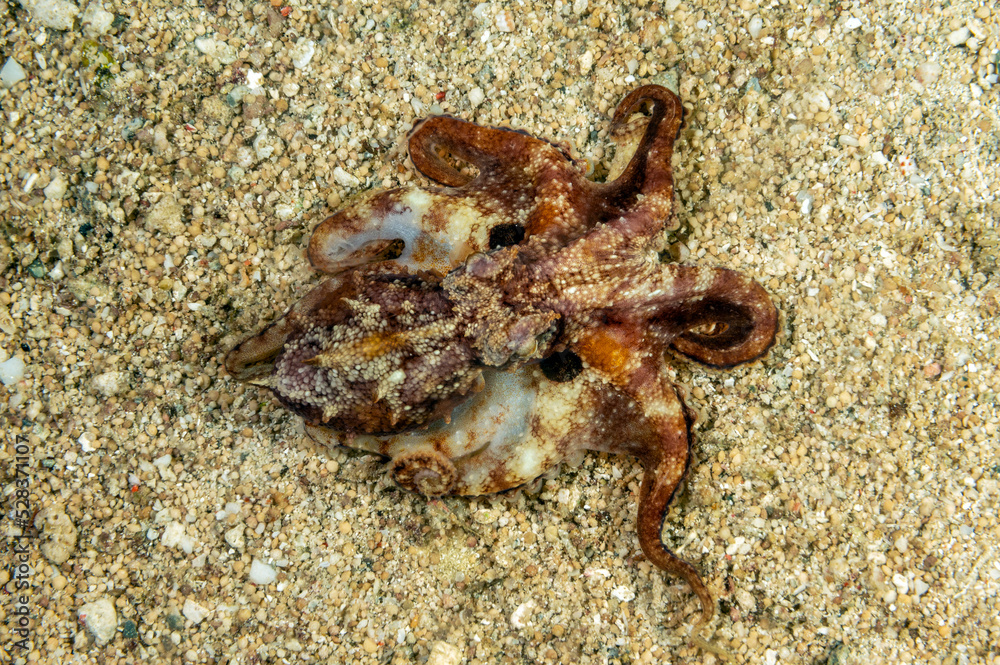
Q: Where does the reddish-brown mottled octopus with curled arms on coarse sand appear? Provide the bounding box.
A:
[225,85,778,623]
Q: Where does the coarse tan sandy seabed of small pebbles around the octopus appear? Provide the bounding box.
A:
[0,0,1000,665]
